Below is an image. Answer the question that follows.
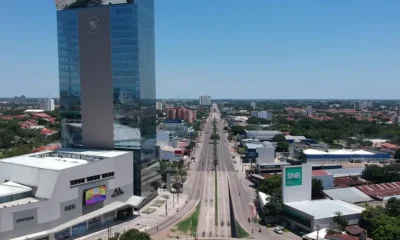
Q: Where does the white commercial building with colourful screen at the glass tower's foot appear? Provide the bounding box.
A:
[0,149,143,240]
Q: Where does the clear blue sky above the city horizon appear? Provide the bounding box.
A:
[0,0,400,99]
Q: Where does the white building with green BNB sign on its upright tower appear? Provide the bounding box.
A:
[282,163,364,232]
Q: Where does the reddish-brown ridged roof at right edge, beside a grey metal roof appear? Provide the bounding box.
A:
[357,182,400,199]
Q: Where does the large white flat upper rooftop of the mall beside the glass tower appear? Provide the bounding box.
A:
[1,148,128,171]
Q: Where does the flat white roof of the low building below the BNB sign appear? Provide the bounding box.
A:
[285,200,364,219]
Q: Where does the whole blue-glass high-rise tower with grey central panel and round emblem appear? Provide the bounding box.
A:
[56,0,160,202]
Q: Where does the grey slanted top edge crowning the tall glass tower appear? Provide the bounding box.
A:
[55,0,133,10]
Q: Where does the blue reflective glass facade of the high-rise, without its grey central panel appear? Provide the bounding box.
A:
[57,0,159,199]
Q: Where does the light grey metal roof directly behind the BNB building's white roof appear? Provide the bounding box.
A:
[324,187,373,203]
